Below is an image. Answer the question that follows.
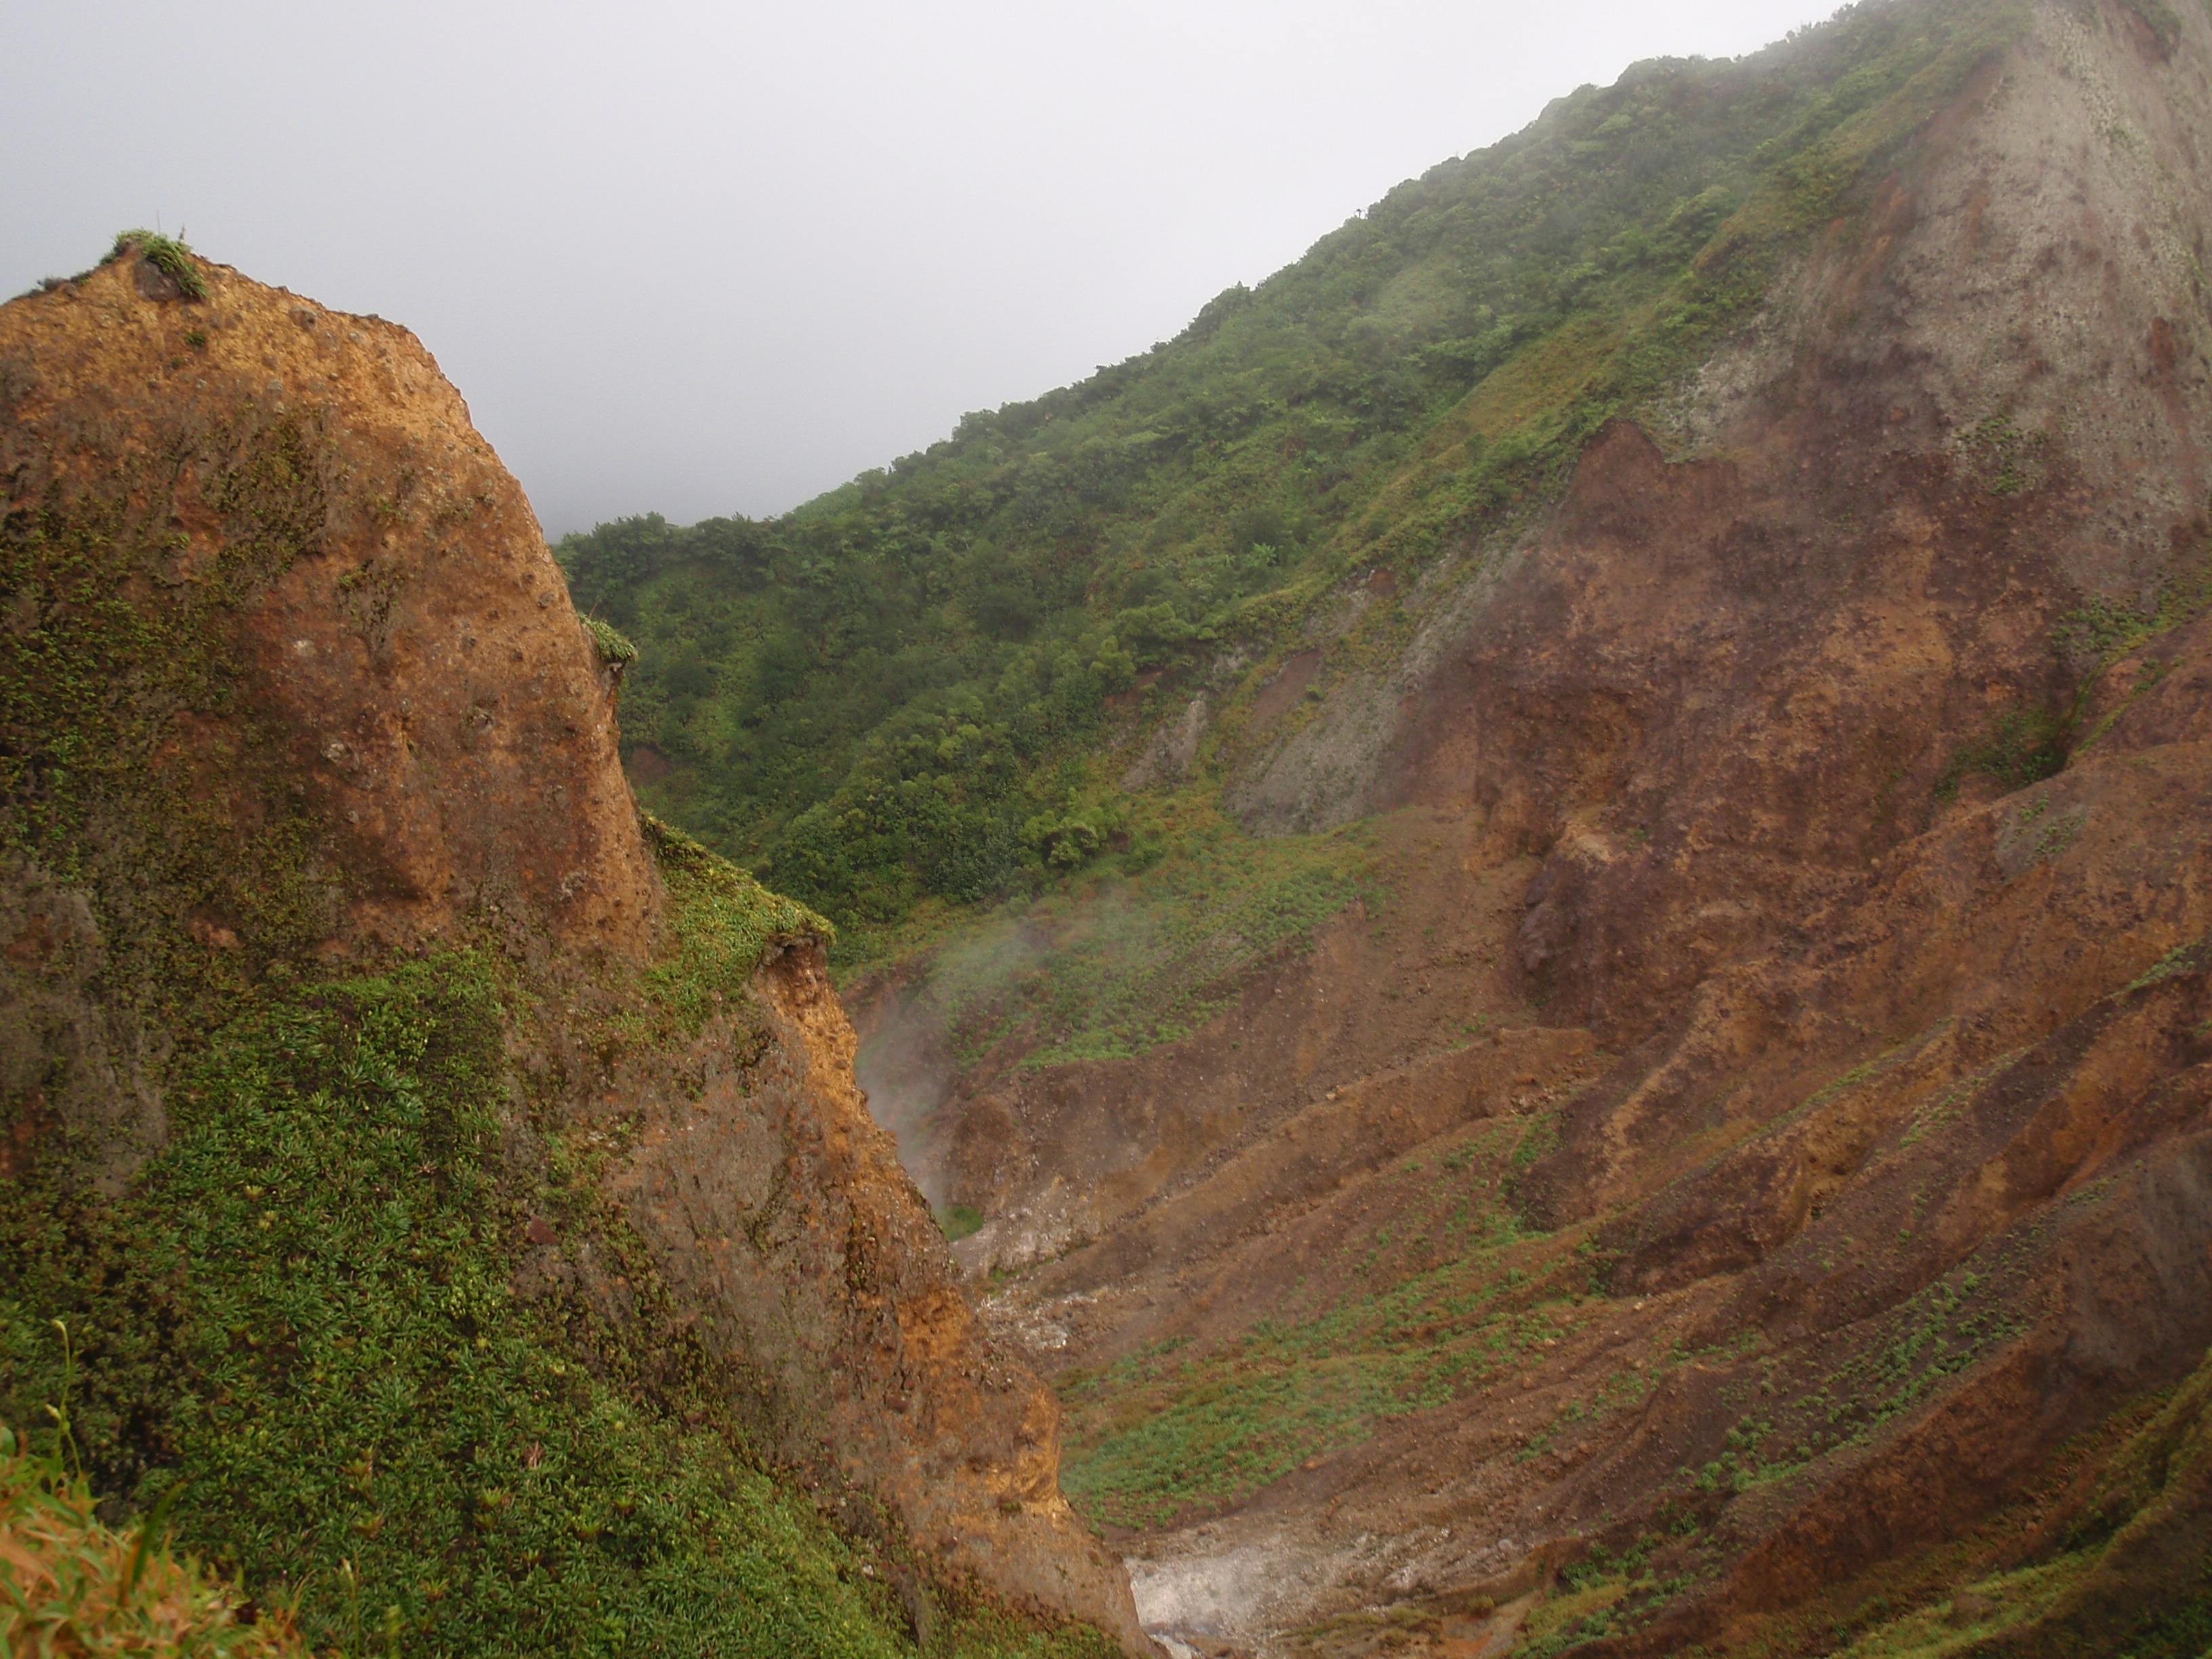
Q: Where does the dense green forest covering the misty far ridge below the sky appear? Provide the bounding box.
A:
[560,0,2018,954]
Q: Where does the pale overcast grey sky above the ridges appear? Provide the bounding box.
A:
[0,0,1834,537]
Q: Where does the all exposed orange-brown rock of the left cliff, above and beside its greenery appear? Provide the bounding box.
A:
[0,250,1148,1652]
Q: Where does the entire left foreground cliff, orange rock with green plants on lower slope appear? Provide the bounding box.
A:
[0,237,1148,1652]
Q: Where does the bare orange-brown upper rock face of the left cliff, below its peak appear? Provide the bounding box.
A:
[0,257,657,960]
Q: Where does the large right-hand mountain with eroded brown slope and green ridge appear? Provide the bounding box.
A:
[564,0,2212,1654]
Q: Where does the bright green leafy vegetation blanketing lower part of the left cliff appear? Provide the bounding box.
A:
[0,954,1111,1659]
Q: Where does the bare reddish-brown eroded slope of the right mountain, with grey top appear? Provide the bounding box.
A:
[862,0,2212,1652]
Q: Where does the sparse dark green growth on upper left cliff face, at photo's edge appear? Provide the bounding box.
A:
[0,411,343,1031]
